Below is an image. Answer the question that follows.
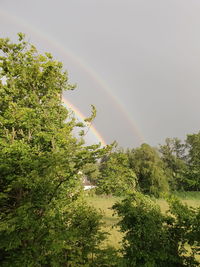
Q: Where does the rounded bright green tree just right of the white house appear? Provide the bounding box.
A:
[97,152,137,196]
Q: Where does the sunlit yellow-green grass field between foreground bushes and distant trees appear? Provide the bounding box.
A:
[87,192,200,248]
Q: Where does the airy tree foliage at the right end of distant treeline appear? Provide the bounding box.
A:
[159,136,200,191]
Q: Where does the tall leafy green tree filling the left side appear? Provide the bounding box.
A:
[0,34,105,266]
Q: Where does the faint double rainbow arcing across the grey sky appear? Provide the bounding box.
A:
[0,9,144,146]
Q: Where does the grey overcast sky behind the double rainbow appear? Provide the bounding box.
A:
[0,0,200,147]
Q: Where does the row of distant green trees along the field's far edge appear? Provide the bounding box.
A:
[84,135,200,197]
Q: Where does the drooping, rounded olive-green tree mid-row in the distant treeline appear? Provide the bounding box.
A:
[129,144,169,197]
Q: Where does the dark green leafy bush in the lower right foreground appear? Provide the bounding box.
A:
[113,193,199,267]
